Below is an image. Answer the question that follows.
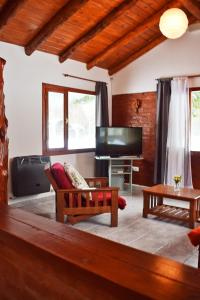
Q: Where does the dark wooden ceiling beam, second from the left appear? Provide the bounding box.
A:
[25,0,89,55]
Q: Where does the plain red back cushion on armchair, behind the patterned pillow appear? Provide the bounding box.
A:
[51,163,74,189]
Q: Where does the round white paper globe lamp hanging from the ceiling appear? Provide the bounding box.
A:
[159,8,188,39]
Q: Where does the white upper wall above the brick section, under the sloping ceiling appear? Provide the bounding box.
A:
[112,31,200,95]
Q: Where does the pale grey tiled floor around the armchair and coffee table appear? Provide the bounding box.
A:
[11,188,198,267]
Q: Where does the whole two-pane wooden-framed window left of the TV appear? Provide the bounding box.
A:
[43,83,96,155]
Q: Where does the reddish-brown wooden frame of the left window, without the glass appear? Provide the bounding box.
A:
[42,83,96,155]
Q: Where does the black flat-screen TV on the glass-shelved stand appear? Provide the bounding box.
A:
[96,127,142,157]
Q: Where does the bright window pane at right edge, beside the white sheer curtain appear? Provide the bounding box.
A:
[191,89,200,151]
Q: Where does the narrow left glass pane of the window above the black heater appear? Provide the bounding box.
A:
[48,92,64,149]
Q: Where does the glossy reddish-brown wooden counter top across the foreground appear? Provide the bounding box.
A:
[0,203,200,300]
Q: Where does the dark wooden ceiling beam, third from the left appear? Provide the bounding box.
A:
[59,0,137,62]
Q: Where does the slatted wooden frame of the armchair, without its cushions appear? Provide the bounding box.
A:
[45,166,119,227]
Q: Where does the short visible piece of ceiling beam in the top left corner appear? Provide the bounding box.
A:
[0,0,26,29]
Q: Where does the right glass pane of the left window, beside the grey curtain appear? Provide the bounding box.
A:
[68,92,96,149]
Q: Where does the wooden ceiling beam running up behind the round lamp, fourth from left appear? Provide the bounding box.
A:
[87,0,181,70]
